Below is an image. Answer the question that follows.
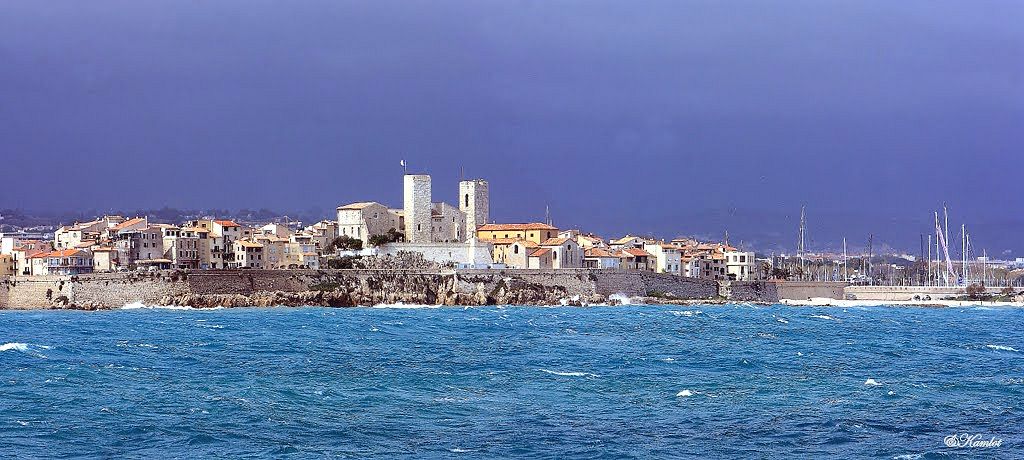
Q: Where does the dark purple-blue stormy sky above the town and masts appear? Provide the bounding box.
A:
[0,0,1024,255]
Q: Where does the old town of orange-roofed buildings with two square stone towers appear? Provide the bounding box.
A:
[0,174,769,281]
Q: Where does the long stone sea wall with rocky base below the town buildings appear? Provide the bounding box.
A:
[0,269,737,309]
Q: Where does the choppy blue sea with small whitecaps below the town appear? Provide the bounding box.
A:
[0,305,1024,459]
